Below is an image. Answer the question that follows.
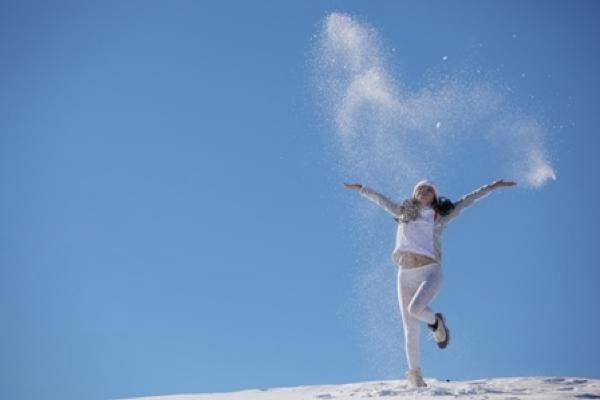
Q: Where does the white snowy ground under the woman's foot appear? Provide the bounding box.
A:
[123,377,600,400]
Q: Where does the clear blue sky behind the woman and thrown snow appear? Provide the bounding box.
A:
[0,1,600,400]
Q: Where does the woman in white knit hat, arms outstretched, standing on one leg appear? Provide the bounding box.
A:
[344,180,516,387]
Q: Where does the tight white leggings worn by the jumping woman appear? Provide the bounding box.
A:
[398,264,442,369]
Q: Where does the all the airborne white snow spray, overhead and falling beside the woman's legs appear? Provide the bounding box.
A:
[311,13,556,374]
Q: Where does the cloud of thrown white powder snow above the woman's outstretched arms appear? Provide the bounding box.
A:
[313,13,555,191]
